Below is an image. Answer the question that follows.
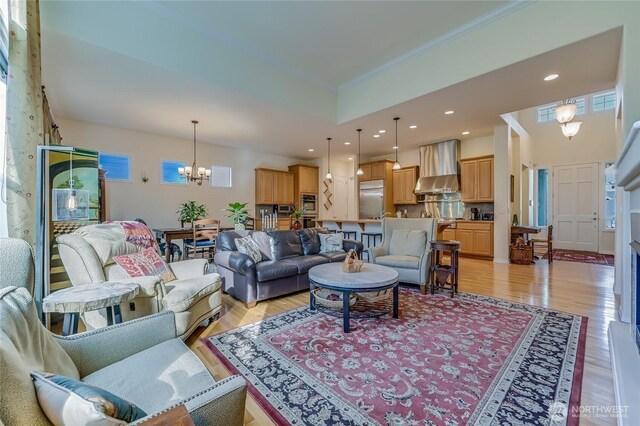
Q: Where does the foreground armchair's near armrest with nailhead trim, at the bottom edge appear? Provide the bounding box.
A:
[132,376,247,426]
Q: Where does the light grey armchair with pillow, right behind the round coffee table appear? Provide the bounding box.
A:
[369,219,437,293]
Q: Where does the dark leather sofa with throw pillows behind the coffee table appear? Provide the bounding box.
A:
[214,228,362,308]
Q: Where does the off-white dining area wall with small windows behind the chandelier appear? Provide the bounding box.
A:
[57,119,308,227]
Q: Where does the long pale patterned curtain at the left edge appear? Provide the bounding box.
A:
[5,0,44,246]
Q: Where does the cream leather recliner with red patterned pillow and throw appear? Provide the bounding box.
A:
[56,222,222,339]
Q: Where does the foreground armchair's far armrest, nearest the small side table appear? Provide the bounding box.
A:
[54,311,177,377]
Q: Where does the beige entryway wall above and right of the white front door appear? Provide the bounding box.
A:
[518,100,617,254]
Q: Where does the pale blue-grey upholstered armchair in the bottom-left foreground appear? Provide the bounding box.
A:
[0,287,247,426]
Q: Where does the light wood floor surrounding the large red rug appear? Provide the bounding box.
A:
[187,258,615,426]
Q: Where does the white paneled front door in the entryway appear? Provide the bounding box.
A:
[553,163,598,252]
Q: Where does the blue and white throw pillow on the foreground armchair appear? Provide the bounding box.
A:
[31,372,147,426]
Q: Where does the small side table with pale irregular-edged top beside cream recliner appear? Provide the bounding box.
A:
[42,281,140,336]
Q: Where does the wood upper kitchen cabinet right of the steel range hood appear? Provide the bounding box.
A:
[460,155,493,202]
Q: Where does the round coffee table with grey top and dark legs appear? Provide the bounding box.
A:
[309,263,398,333]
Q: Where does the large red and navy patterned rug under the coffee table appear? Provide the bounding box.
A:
[204,288,587,426]
